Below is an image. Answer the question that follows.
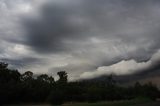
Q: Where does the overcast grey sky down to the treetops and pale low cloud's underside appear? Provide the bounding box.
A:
[0,0,160,80]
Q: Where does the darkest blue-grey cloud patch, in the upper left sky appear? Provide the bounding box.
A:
[25,3,89,53]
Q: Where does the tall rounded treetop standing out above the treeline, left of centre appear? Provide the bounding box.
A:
[57,71,68,83]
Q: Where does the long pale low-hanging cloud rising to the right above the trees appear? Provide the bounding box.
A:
[80,50,160,79]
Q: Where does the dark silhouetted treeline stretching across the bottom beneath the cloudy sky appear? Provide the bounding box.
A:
[0,62,160,104]
